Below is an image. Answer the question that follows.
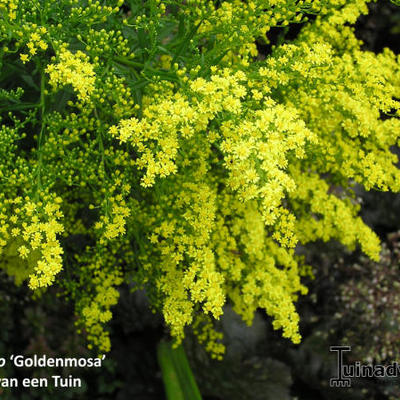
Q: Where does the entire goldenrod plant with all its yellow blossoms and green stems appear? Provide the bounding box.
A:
[0,0,400,358]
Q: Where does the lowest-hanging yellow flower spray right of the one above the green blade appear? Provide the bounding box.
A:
[214,194,307,343]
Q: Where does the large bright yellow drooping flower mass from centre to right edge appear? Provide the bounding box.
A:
[109,23,399,343]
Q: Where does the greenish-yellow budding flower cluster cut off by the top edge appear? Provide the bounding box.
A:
[185,0,334,66]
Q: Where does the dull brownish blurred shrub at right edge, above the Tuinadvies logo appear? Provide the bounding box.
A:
[335,233,400,363]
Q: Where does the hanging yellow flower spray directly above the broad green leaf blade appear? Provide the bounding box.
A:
[145,181,225,342]
